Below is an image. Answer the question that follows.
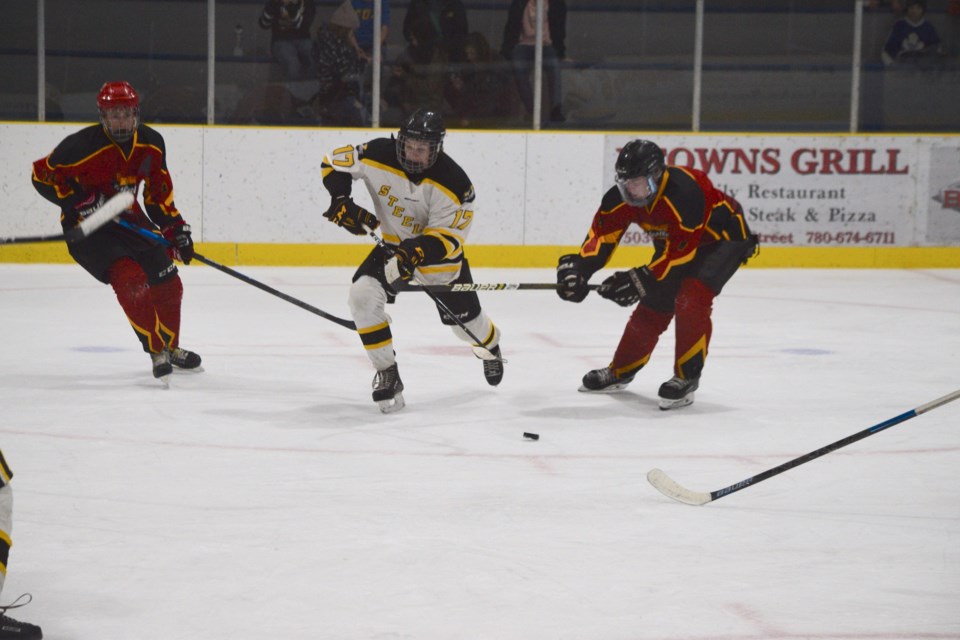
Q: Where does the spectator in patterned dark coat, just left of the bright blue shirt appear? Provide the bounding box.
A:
[315,0,369,126]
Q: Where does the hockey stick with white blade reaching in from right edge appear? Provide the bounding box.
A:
[647,389,960,506]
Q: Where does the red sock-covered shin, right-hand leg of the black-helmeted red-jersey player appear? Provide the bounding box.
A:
[674,280,716,380]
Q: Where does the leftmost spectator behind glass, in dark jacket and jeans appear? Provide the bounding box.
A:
[259,0,317,80]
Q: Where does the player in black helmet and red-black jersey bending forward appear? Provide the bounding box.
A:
[557,140,758,409]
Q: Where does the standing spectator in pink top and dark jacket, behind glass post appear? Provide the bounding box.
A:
[500,0,567,122]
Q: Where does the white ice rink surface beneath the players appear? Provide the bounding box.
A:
[0,265,960,640]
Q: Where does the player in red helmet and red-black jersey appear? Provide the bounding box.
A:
[33,82,200,382]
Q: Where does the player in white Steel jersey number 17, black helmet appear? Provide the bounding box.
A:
[322,109,503,413]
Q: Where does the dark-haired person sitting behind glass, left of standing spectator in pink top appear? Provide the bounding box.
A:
[446,31,521,127]
